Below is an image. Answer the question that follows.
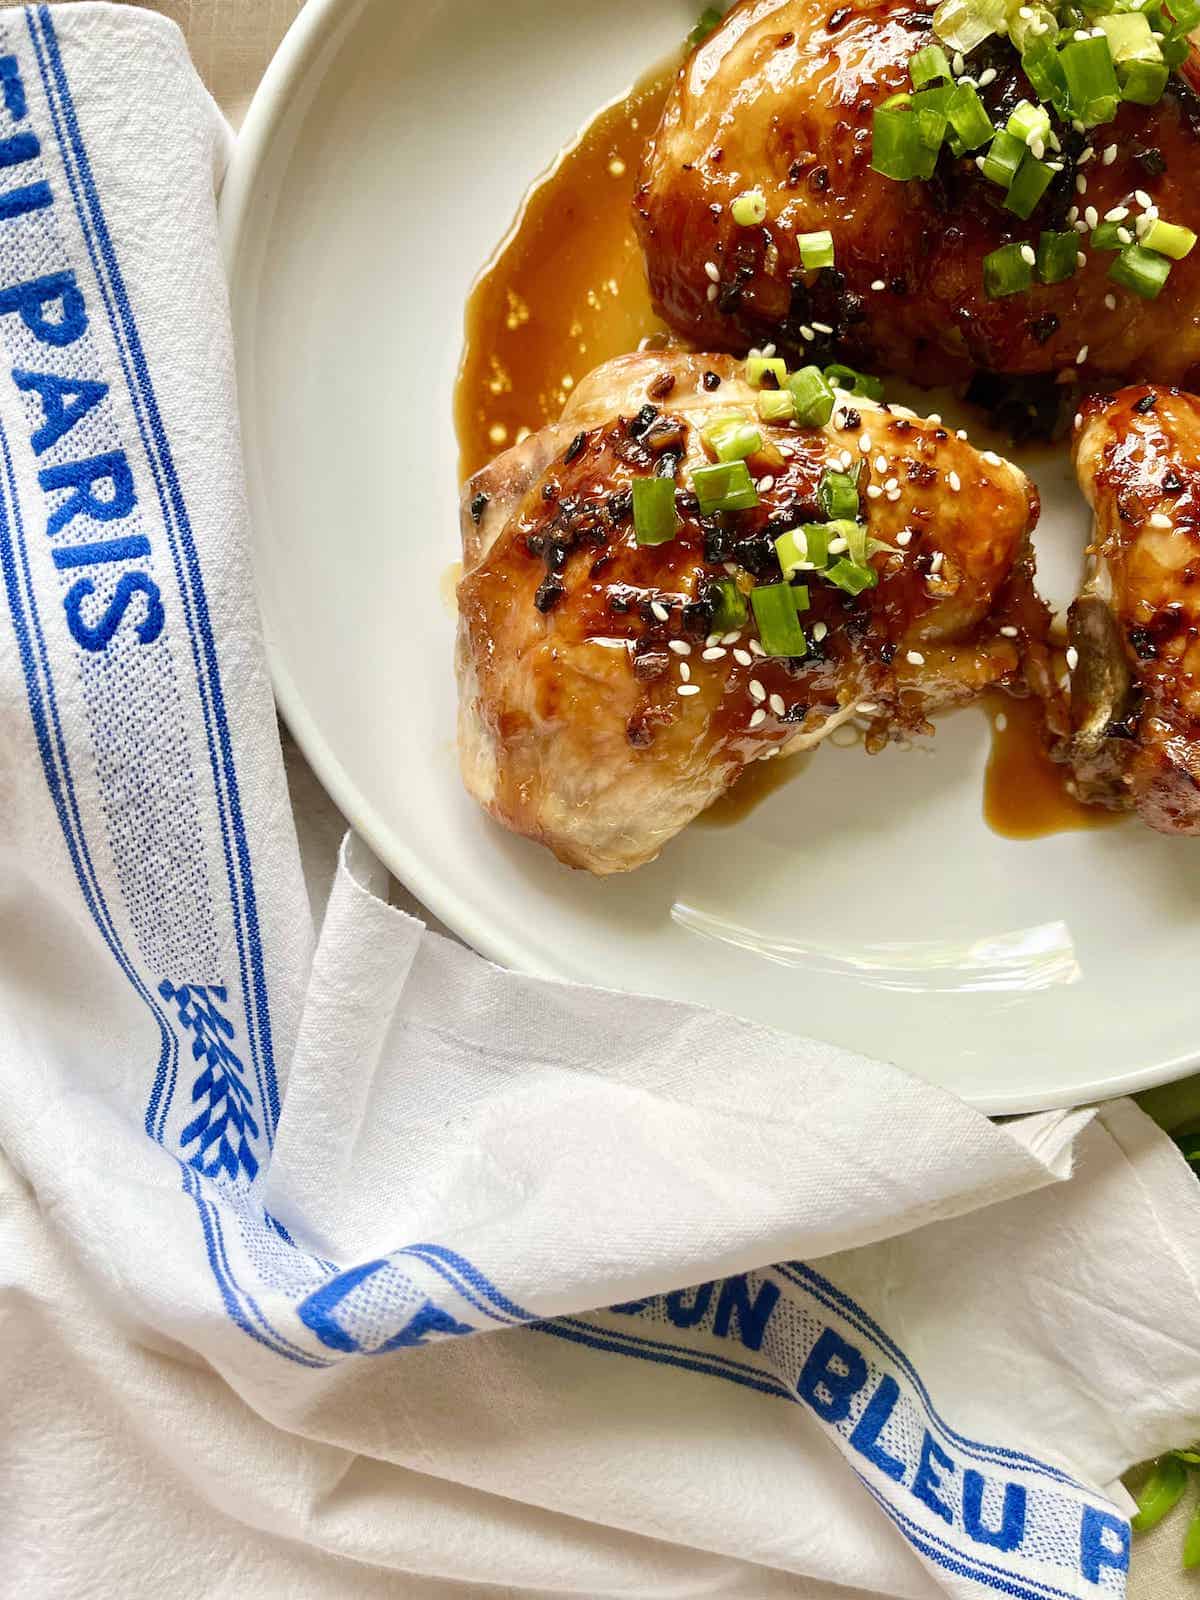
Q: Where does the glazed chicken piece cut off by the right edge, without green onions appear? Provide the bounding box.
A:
[1070,384,1200,834]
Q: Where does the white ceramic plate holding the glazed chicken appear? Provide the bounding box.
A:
[222,0,1200,1112]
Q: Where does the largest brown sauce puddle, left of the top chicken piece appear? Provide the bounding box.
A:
[454,61,677,478]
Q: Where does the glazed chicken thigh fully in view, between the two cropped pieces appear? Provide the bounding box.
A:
[458,352,1054,874]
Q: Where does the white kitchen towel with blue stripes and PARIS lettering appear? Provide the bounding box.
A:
[0,5,1200,1600]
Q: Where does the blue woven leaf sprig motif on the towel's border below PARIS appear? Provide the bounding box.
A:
[158,978,258,1179]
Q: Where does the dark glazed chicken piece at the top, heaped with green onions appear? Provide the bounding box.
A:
[635,0,1200,382]
